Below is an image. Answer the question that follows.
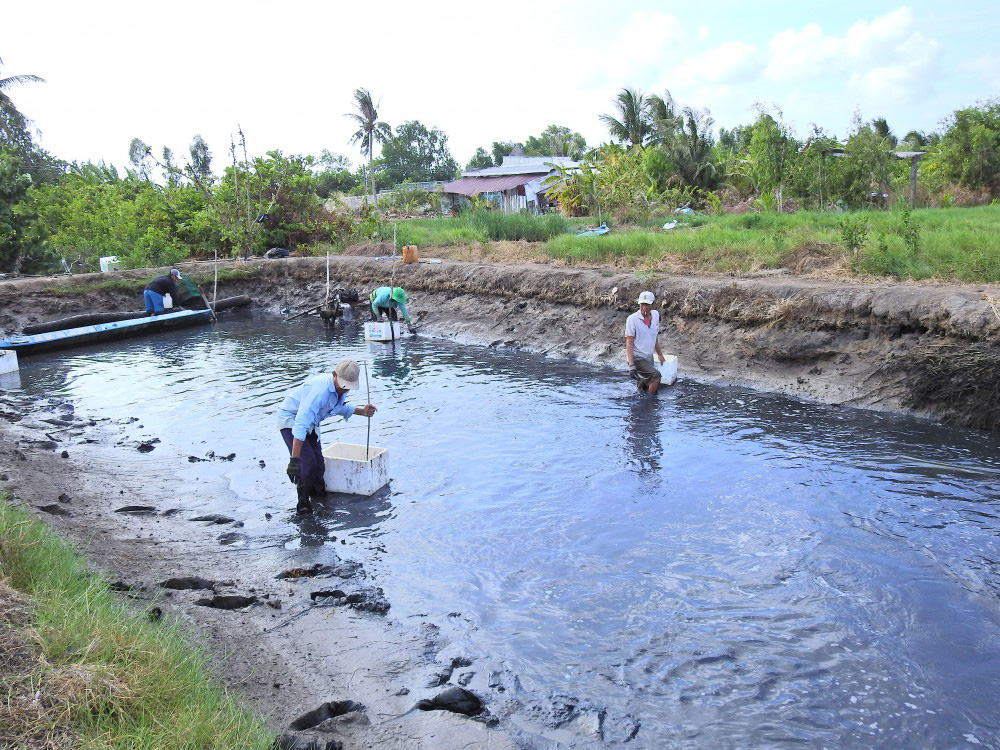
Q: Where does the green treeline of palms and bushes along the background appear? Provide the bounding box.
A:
[0,61,1000,274]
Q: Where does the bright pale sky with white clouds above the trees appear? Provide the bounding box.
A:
[0,0,1000,168]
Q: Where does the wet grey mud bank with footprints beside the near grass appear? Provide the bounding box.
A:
[0,391,515,750]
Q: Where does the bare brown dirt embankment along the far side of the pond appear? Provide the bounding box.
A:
[0,257,1000,430]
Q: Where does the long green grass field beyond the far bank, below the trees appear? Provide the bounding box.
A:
[392,205,1000,283]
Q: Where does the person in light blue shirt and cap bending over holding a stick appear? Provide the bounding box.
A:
[278,359,375,513]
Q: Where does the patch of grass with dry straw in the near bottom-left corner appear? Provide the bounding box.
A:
[0,496,274,750]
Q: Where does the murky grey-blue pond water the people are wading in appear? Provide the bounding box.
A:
[9,316,1000,748]
